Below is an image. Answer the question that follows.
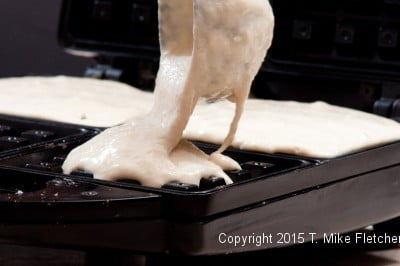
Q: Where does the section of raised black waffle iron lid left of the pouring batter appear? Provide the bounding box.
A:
[59,0,159,57]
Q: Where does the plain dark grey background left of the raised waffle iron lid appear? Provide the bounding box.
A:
[0,0,93,77]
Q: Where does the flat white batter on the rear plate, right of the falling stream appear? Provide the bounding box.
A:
[184,99,400,158]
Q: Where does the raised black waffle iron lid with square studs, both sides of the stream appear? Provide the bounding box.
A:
[59,0,400,78]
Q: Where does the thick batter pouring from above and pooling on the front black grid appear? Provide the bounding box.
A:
[63,0,274,187]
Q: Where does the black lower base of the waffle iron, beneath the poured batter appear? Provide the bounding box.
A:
[0,115,400,255]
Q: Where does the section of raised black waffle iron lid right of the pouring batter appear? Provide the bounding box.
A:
[269,0,400,78]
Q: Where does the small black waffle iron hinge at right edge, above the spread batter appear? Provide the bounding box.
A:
[374,83,400,122]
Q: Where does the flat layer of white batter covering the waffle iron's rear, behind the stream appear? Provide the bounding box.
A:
[0,77,400,161]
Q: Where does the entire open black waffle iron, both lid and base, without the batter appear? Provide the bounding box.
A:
[0,0,400,255]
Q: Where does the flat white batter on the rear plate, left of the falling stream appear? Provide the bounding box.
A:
[0,76,154,127]
